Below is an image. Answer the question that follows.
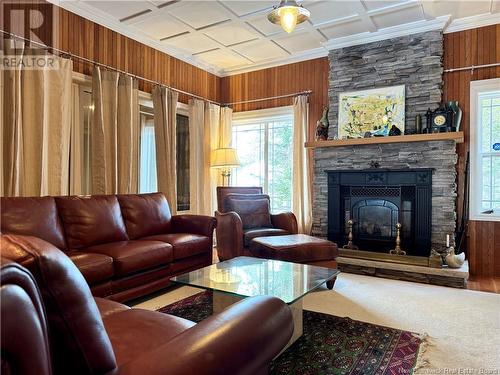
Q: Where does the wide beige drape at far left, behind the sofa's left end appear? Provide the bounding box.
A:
[1,40,72,196]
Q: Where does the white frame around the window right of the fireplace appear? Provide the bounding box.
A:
[469,78,500,221]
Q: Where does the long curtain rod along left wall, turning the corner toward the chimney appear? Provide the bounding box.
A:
[0,29,312,107]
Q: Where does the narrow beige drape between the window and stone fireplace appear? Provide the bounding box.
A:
[292,95,312,234]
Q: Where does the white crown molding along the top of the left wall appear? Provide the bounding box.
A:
[47,0,222,77]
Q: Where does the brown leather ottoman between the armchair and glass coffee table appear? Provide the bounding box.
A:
[250,234,338,289]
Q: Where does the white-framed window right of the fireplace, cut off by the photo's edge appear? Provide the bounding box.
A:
[470,79,500,221]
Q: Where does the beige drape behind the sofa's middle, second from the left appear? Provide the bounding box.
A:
[91,67,140,194]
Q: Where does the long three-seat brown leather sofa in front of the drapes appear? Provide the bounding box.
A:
[0,193,216,301]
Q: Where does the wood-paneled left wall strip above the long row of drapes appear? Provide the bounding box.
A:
[3,0,221,102]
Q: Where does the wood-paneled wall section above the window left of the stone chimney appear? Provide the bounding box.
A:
[221,57,328,139]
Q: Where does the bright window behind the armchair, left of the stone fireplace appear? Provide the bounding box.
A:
[232,107,293,213]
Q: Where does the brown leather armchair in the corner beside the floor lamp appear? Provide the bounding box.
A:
[215,186,298,261]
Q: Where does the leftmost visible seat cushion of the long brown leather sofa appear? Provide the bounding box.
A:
[67,251,113,286]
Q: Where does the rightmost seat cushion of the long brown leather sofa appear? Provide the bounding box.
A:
[142,233,212,259]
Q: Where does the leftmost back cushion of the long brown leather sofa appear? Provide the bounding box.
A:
[0,197,66,250]
